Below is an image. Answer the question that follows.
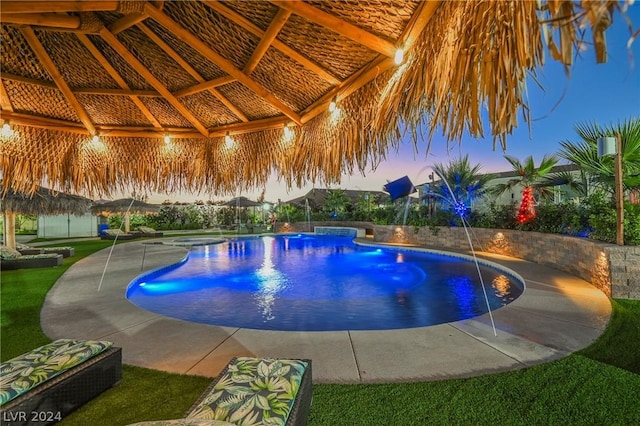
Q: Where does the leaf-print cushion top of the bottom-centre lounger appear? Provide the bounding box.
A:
[187,357,308,426]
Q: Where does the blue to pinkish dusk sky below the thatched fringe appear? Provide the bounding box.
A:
[149,4,640,202]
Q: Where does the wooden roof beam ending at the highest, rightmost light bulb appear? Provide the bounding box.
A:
[270,0,397,58]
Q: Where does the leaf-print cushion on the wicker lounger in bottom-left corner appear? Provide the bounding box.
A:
[0,339,113,405]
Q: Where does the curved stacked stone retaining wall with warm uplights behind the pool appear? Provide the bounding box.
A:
[374,225,640,300]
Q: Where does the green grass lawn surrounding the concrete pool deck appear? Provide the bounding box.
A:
[0,241,640,426]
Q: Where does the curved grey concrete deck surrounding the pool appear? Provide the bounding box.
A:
[41,241,611,383]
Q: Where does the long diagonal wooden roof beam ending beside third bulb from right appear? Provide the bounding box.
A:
[144,3,300,123]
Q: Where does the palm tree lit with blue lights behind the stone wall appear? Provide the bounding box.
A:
[426,155,493,213]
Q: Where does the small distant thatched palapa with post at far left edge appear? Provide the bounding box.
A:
[0,187,91,248]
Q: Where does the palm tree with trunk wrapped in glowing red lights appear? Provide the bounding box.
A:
[492,154,559,223]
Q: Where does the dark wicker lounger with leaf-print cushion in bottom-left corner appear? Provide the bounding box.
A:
[0,339,122,426]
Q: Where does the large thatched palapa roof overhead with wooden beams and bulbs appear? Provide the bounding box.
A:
[0,0,632,196]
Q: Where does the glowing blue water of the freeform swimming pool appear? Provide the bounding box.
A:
[127,234,524,331]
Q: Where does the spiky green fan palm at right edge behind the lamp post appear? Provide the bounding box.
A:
[559,117,640,192]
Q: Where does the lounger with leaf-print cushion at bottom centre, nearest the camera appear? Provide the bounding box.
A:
[123,357,312,426]
